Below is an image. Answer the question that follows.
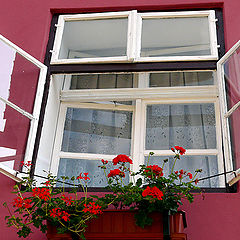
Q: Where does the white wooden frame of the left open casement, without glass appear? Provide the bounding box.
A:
[0,35,47,181]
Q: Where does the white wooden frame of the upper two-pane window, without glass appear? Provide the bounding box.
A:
[51,10,218,64]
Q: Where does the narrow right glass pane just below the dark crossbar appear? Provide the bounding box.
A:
[149,71,214,87]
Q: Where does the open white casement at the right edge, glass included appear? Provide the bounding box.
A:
[217,41,240,181]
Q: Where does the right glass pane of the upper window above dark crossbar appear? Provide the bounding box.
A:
[141,17,211,57]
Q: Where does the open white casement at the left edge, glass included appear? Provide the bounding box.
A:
[0,35,47,181]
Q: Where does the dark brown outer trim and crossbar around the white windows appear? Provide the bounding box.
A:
[30,7,232,193]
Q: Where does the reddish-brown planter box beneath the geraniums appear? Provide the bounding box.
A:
[47,210,187,240]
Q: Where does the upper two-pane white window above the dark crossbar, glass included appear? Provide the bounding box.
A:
[51,10,218,64]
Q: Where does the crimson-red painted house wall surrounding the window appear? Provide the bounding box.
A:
[0,0,240,240]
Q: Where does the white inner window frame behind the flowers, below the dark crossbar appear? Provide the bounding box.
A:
[50,70,225,187]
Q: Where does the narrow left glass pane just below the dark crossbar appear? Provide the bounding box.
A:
[70,74,133,89]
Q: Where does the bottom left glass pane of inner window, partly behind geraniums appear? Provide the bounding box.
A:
[57,158,129,187]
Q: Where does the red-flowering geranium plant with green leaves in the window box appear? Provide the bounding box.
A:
[4,146,201,239]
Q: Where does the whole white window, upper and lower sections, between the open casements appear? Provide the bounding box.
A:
[31,11,233,188]
